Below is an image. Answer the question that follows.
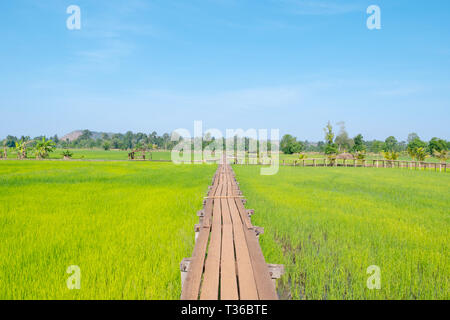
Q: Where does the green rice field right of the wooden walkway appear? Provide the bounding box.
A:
[234,166,450,299]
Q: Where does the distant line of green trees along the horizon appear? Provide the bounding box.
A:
[2,122,450,161]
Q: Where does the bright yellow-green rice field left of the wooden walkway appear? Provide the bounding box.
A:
[0,161,216,299]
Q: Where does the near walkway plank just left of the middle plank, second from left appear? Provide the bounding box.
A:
[200,184,223,300]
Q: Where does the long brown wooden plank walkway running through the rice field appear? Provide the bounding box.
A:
[180,164,283,300]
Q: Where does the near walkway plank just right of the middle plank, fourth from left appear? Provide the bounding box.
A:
[227,199,258,300]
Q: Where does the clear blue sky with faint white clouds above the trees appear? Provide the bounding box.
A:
[0,0,450,141]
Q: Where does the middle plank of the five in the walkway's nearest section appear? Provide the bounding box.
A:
[220,199,239,300]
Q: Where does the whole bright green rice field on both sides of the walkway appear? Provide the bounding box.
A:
[0,161,450,300]
